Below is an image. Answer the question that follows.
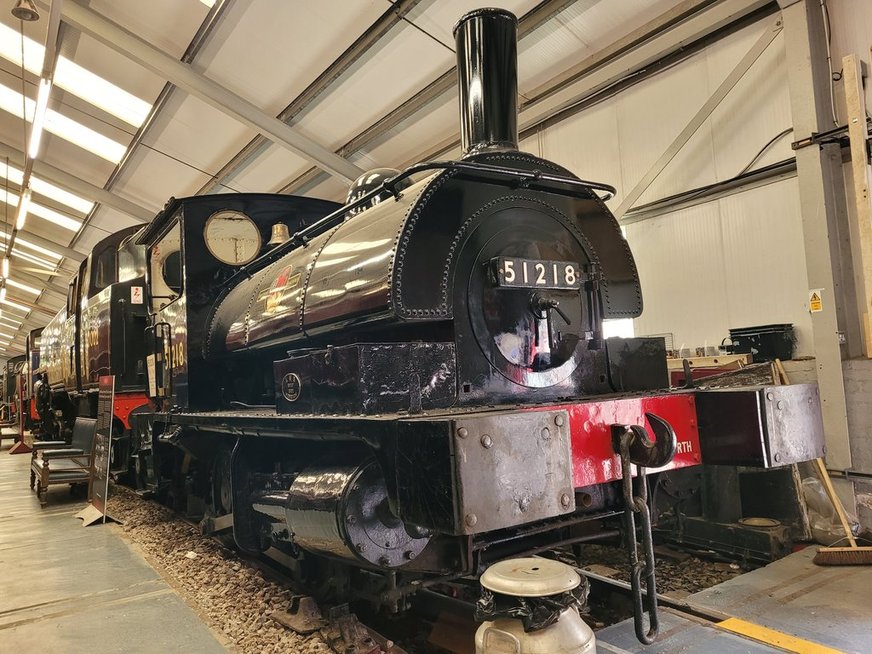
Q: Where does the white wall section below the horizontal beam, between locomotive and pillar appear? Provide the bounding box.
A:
[627,177,813,355]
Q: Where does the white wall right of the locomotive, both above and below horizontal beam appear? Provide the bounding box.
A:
[522,14,820,354]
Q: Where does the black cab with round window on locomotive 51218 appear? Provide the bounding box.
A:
[137,193,338,409]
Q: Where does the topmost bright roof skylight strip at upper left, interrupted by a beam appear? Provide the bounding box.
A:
[0,23,151,127]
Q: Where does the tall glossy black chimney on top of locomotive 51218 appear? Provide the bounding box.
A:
[454,9,518,156]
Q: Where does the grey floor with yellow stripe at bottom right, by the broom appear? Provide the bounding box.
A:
[597,547,872,654]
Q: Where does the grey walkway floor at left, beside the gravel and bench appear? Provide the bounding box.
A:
[0,441,228,654]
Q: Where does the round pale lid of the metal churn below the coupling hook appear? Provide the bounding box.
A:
[481,557,581,597]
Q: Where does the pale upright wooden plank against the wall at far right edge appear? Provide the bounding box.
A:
[842,54,872,358]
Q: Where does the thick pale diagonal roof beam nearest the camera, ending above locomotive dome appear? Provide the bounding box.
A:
[62,0,363,181]
